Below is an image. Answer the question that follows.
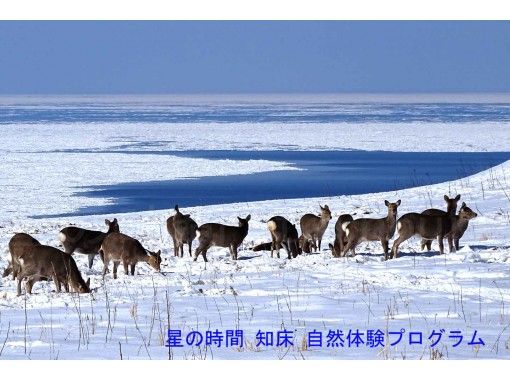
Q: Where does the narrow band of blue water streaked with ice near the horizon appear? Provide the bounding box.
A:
[0,98,510,124]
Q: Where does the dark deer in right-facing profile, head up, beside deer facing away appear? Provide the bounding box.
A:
[193,215,251,262]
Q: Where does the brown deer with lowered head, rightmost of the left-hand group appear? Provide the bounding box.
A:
[99,232,161,280]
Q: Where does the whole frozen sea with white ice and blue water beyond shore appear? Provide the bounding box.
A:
[0,95,510,218]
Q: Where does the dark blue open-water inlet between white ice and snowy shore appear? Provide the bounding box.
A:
[41,151,510,215]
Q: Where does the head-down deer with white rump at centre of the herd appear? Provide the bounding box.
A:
[267,216,301,259]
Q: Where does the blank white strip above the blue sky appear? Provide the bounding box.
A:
[0,0,510,20]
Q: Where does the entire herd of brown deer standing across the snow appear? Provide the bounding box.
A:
[3,195,477,295]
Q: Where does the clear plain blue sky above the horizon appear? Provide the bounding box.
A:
[0,21,510,94]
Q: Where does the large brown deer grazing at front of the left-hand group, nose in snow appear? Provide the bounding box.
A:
[17,244,90,296]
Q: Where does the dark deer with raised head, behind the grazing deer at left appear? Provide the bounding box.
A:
[58,218,120,269]
